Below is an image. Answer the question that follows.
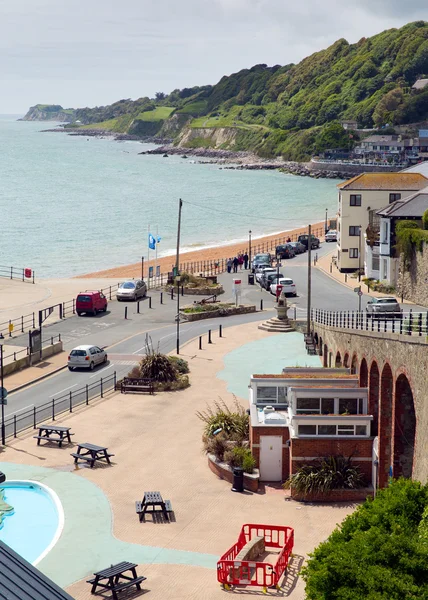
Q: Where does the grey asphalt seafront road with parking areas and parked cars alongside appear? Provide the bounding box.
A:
[5,244,424,426]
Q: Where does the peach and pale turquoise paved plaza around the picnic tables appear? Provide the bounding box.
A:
[0,323,353,600]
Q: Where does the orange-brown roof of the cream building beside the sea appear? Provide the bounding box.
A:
[337,171,428,192]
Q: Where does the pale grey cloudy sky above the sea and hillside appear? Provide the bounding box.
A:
[0,0,427,114]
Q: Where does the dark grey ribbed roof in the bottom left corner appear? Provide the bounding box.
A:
[0,541,73,600]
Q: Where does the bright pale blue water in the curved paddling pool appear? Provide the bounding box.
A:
[0,483,59,563]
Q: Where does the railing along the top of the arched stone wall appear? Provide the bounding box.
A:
[311,309,428,337]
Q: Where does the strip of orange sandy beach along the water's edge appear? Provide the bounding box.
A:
[78,222,324,279]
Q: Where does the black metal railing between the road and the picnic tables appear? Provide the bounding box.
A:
[5,371,116,439]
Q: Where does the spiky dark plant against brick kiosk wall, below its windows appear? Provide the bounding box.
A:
[284,455,366,496]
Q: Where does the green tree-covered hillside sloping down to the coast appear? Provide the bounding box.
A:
[22,21,428,160]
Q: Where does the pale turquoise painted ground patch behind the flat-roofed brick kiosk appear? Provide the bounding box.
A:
[217,331,322,400]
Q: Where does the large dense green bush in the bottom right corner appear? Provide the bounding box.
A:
[302,479,428,600]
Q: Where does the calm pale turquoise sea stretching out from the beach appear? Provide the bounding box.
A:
[0,117,337,277]
